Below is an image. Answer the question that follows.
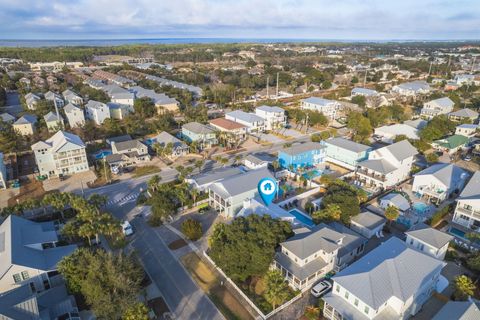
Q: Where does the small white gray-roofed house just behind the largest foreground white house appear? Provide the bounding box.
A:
[405,222,453,260]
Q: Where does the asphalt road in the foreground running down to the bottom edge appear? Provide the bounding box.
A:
[131,218,224,320]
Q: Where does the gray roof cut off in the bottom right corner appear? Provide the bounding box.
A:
[432,300,480,320]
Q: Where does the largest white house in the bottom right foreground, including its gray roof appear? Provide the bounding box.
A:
[323,237,446,320]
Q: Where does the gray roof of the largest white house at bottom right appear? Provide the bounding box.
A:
[332,237,445,309]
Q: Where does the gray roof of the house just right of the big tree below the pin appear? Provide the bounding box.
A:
[280,223,345,259]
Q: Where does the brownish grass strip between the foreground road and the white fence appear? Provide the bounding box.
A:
[181,252,253,320]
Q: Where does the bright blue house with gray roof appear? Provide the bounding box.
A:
[278,142,325,171]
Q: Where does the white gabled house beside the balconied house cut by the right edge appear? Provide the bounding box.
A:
[412,163,469,204]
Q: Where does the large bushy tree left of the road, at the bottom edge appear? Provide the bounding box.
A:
[58,248,143,319]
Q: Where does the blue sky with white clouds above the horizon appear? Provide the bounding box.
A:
[0,0,480,40]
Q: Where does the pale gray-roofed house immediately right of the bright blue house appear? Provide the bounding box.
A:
[322,138,372,170]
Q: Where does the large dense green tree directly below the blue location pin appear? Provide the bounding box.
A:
[209,214,292,281]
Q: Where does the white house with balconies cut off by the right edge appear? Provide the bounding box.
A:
[452,171,480,233]
